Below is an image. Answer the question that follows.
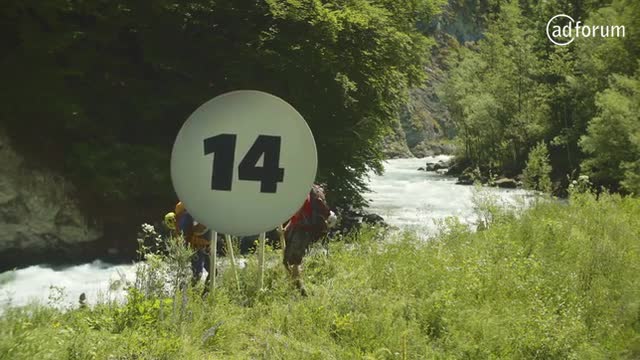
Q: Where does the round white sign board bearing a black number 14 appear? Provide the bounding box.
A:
[171,90,318,236]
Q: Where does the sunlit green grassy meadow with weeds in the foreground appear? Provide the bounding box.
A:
[0,194,640,359]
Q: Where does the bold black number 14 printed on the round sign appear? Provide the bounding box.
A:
[204,134,284,193]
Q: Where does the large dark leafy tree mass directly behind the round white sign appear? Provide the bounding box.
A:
[0,0,444,219]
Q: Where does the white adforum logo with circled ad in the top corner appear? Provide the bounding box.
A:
[547,14,625,46]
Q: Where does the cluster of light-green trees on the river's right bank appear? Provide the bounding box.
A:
[442,0,640,192]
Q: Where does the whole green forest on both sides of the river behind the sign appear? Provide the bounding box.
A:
[0,0,640,228]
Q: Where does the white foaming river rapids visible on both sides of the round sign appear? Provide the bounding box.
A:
[0,156,530,312]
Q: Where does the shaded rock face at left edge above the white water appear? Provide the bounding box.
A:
[0,129,103,271]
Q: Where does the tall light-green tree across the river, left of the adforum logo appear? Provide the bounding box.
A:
[443,2,547,175]
